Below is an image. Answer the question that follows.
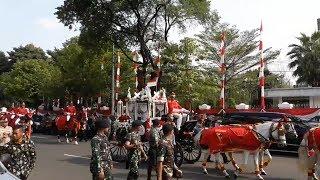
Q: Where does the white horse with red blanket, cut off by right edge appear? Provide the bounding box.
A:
[298,127,320,180]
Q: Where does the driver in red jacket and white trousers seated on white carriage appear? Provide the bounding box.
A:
[168,92,189,130]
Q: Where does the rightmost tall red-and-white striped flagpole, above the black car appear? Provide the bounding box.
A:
[259,21,266,110]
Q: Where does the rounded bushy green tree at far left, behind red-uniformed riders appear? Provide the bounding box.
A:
[0,60,61,102]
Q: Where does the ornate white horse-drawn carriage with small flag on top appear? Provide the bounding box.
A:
[111,89,188,166]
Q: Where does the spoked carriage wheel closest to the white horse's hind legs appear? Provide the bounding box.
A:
[182,142,201,164]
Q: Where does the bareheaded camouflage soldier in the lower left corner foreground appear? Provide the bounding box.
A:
[0,125,36,180]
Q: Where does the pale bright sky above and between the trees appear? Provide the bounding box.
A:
[0,0,320,83]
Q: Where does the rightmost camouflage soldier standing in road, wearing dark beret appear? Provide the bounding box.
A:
[157,124,182,180]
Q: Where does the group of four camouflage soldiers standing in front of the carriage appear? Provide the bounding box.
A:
[90,115,182,180]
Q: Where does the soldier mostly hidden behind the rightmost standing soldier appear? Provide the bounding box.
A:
[148,119,161,180]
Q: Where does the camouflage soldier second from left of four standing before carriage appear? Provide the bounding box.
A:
[125,120,142,180]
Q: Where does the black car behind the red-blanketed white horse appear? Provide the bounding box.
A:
[221,112,311,153]
